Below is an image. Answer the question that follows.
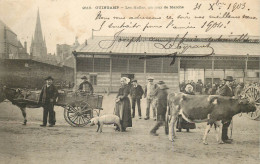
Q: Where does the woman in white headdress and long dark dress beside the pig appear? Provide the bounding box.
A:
[114,77,132,131]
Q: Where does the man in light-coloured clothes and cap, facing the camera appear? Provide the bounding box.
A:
[144,76,157,120]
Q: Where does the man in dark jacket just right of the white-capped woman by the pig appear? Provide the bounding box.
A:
[130,80,144,119]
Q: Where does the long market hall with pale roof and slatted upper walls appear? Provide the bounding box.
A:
[73,35,260,92]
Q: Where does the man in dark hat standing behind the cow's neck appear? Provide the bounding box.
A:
[219,76,234,143]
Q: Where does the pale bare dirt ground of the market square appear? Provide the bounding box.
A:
[0,95,260,164]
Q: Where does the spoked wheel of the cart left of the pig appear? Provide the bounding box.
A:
[64,105,91,127]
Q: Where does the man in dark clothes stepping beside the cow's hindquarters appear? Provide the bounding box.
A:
[150,81,169,136]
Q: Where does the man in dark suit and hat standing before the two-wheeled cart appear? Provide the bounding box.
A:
[39,76,58,127]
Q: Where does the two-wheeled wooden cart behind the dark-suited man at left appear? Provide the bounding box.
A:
[14,90,103,127]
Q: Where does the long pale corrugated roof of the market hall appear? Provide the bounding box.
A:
[76,36,260,56]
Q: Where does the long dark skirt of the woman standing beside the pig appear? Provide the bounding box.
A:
[114,98,132,128]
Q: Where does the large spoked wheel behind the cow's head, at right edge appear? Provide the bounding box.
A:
[244,86,260,121]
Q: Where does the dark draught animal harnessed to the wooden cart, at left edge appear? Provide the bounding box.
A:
[0,87,41,125]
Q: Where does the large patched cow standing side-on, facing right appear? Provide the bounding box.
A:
[165,93,256,145]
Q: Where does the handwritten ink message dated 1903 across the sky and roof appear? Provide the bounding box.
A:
[84,0,259,62]
